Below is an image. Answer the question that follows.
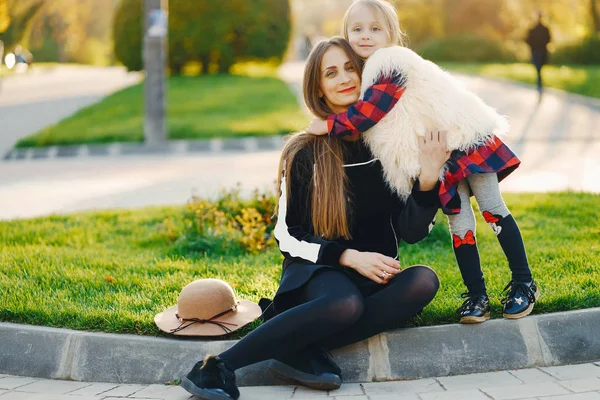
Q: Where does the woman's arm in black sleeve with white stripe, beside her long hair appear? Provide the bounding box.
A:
[274,148,346,265]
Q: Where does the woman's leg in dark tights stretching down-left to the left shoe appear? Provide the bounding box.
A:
[219,269,364,370]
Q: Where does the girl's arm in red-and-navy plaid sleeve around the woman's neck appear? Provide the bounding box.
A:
[307,74,406,137]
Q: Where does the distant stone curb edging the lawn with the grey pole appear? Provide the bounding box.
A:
[4,136,283,161]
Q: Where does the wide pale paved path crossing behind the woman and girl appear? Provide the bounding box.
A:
[0,63,600,219]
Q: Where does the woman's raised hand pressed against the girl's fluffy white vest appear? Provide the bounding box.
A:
[419,131,451,191]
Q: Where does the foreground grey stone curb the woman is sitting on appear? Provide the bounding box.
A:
[0,308,600,386]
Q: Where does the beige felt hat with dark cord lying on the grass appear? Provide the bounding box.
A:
[154,279,261,336]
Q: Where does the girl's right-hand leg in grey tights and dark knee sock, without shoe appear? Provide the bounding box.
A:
[467,174,532,282]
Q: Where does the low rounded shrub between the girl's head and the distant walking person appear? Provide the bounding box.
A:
[417,34,515,62]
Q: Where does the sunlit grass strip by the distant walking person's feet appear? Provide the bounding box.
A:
[441,63,600,98]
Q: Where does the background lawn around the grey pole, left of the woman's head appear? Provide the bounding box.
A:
[17,75,308,147]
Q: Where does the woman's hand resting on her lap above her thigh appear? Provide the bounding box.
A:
[340,249,402,284]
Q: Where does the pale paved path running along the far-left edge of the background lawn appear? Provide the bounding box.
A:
[0,66,141,155]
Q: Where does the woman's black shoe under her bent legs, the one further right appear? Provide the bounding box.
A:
[269,347,342,390]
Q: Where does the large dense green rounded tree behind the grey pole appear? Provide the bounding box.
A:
[113,0,291,75]
